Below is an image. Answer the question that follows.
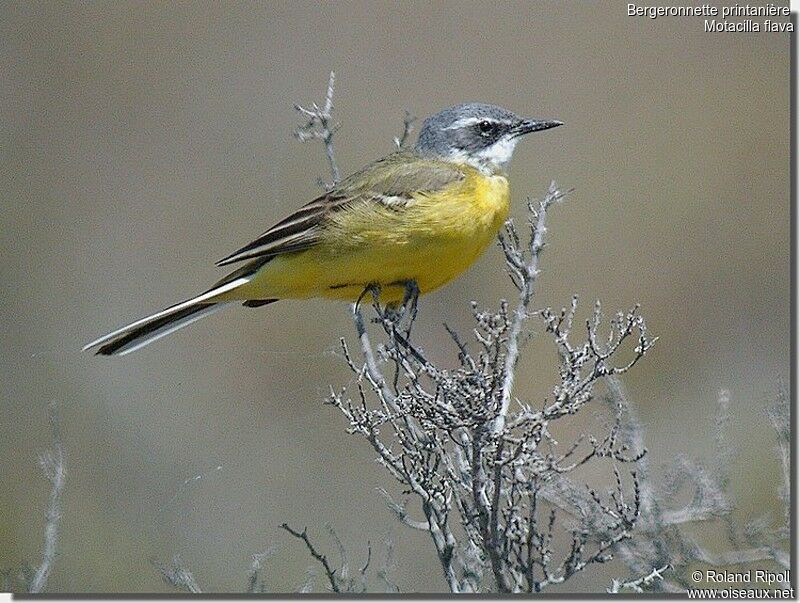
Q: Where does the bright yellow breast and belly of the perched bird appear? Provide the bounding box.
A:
[236,171,509,303]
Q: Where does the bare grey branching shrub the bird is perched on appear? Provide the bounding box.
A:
[329,185,654,592]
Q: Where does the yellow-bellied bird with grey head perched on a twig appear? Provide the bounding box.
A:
[83,103,563,356]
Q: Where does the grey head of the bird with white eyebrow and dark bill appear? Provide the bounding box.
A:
[415,103,562,173]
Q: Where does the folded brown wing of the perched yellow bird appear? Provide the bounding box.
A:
[217,152,464,266]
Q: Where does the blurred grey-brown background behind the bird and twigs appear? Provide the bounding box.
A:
[0,1,790,592]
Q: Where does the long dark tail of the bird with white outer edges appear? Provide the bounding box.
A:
[83,277,275,356]
